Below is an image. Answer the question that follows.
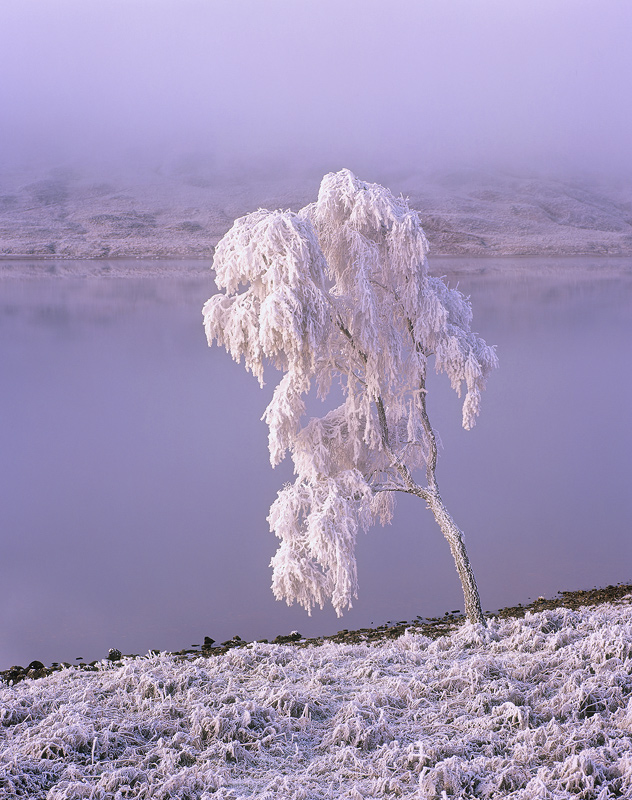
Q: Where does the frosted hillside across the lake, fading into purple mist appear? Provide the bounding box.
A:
[0,160,632,259]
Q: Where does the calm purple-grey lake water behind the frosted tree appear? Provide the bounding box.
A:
[0,262,632,668]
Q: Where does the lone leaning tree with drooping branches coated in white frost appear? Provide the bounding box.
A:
[204,170,497,623]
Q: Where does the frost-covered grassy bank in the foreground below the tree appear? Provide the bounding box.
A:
[0,596,632,800]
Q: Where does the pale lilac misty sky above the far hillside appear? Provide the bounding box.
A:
[0,0,632,174]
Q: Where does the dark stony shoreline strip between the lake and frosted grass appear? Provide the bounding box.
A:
[0,583,632,686]
